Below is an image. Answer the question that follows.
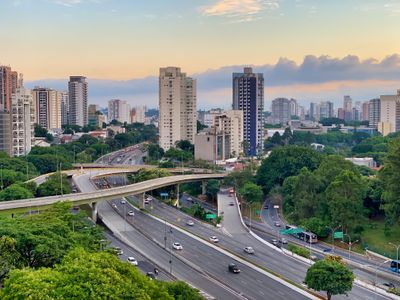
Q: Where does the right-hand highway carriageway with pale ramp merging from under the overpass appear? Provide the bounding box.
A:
[130,194,392,299]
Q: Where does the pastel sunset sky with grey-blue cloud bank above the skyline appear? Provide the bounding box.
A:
[0,0,400,109]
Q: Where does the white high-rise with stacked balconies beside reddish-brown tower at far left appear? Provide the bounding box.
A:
[11,87,34,156]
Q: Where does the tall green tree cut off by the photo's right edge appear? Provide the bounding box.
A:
[379,138,400,225]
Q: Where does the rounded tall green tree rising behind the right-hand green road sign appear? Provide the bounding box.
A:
[326,170,366,229]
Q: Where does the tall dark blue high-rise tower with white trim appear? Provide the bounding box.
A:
[232,68,264,156]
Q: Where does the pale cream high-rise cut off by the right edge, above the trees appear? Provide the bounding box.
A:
[378,90,400,136]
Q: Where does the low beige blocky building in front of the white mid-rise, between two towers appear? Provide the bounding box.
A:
[194,127,231,162]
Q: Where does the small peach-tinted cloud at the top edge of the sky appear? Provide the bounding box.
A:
[201,0,279,22]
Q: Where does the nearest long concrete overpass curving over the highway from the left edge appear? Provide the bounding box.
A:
[0,172,226,220]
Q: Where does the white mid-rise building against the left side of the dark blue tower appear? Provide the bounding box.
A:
[212,110,243,157]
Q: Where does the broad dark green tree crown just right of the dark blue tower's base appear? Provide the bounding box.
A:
[257,145,322,193]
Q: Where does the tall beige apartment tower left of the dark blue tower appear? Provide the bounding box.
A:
[159,67,197,150]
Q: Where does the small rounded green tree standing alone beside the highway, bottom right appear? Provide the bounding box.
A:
[304,259,354,300]
